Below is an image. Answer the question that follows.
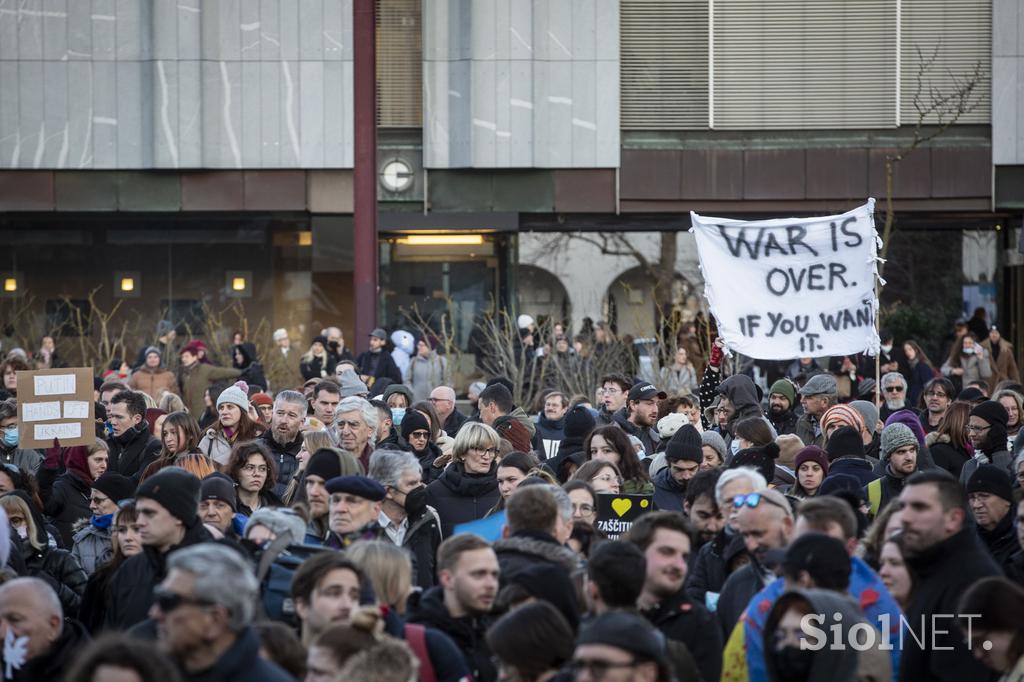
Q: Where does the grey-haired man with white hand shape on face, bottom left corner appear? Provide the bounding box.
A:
[0,578,89,681]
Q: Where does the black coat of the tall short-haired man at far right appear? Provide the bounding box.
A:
[899,527,1001,682]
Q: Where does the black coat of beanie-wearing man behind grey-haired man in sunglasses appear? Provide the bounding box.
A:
[105,523,213,630]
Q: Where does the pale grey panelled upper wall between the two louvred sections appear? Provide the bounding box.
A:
[423,0,620,168]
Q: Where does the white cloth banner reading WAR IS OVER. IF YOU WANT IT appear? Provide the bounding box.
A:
[690,199,885,359]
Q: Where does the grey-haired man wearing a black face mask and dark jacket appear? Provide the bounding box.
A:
[370,450,441,590]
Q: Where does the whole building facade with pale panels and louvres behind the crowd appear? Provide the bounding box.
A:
[0,0,1024,360]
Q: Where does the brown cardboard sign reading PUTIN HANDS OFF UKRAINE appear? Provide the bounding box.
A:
[17,368,96,449]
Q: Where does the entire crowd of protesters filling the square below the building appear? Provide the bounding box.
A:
[0,315,1024,682]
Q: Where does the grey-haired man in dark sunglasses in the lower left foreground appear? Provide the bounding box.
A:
[150,543,292,682]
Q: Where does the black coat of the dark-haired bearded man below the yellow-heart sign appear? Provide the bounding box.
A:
[642,590,723,680]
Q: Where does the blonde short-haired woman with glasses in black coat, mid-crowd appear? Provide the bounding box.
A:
[427,422,501,538]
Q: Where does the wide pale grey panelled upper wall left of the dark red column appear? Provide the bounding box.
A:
[0,0,352,169]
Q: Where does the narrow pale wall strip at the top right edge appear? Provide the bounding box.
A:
[992,0,1024,165]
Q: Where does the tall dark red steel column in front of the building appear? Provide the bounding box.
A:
[352,0,378,349]
